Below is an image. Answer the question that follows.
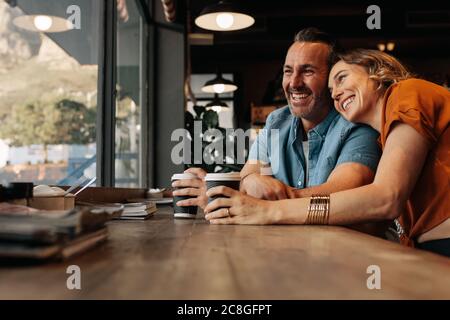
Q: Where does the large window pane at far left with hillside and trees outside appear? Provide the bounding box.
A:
[0,0,102,185]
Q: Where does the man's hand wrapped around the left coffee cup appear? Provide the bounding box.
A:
[172,168,208,209]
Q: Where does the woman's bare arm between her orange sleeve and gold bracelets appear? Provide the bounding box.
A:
[329,123,429,224]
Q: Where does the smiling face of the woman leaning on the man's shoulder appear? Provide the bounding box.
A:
[328,60,380,124]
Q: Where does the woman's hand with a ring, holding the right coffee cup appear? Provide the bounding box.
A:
[204,186,275,224]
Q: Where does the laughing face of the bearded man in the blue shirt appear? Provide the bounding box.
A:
[283,42,330,122]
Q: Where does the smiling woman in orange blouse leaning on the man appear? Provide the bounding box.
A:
[205,49,450,257]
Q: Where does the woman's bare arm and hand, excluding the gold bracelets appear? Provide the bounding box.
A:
[205,123,429,225]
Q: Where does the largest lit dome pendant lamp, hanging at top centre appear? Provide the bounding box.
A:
[195,1,255,31]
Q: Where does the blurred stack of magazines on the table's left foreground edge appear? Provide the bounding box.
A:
[0,203,111,260]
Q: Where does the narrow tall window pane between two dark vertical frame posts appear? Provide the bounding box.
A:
[115,0,147,187]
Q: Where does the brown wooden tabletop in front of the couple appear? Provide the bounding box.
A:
[0,207,450,299]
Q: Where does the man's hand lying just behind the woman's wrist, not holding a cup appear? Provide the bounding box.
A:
[240,173,295,200]
